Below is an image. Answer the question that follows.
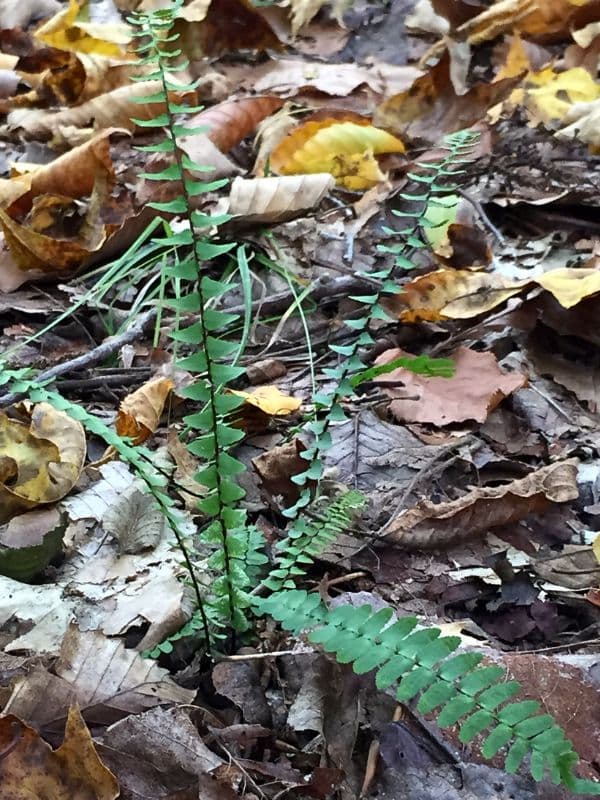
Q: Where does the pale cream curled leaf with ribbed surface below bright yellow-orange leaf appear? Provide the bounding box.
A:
[229,172,335,224]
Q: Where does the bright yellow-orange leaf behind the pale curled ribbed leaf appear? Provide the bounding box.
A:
[270,119,404,188]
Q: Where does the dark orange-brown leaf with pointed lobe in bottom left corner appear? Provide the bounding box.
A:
[0,706,119,800]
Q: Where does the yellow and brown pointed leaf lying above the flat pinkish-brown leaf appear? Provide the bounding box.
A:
[382,269,529,322]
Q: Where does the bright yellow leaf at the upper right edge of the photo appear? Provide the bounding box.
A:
[525,67,600,122]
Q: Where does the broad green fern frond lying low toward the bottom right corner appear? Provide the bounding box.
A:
[256,590,600,795]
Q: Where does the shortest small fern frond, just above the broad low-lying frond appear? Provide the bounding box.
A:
[262,490,367,592]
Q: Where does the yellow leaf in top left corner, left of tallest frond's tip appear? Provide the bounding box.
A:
[34,0,132,58]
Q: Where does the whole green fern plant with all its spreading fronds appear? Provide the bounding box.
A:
[0,2,600,795]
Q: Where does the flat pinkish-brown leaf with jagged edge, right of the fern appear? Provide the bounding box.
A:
[375,347,527,425]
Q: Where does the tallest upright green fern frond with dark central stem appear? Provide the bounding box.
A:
[130,1,250,631]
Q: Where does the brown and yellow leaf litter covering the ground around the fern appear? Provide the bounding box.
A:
[0,0,600,800]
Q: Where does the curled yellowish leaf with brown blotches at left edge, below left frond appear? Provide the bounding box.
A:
[0,403,86,522]
